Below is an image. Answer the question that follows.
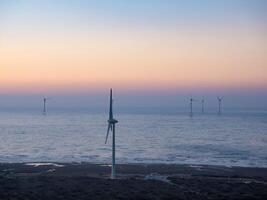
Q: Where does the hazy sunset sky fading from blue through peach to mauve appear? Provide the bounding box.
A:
[0,0,267,109]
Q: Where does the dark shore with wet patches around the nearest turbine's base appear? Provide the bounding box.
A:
[0,163,267,200]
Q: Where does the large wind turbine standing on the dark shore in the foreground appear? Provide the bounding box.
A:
[105,89,118,179]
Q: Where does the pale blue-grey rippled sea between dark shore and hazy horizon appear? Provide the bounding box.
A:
[0,108,267,167]
